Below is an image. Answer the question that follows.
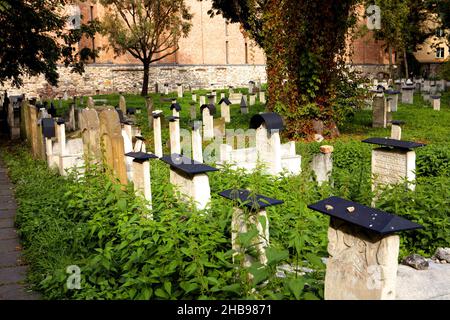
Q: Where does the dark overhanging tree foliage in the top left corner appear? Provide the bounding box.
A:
[0,0,98,86]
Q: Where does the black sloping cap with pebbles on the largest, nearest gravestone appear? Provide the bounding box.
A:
[308,197,423,235]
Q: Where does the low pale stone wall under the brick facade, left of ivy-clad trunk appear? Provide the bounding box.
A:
[2,64,267,96]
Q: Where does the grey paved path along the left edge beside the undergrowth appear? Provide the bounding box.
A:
[0,161,39,300]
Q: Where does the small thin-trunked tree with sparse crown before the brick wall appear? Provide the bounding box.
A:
[100,0,192,96]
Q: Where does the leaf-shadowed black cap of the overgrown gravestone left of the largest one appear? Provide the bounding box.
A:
[219,189,284,210]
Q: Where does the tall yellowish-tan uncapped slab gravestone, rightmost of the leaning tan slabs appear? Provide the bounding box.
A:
[98,109,128,185]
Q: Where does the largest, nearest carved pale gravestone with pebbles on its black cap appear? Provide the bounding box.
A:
[308,197,422,300]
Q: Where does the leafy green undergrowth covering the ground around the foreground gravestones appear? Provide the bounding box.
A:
[1,90,450,299]
